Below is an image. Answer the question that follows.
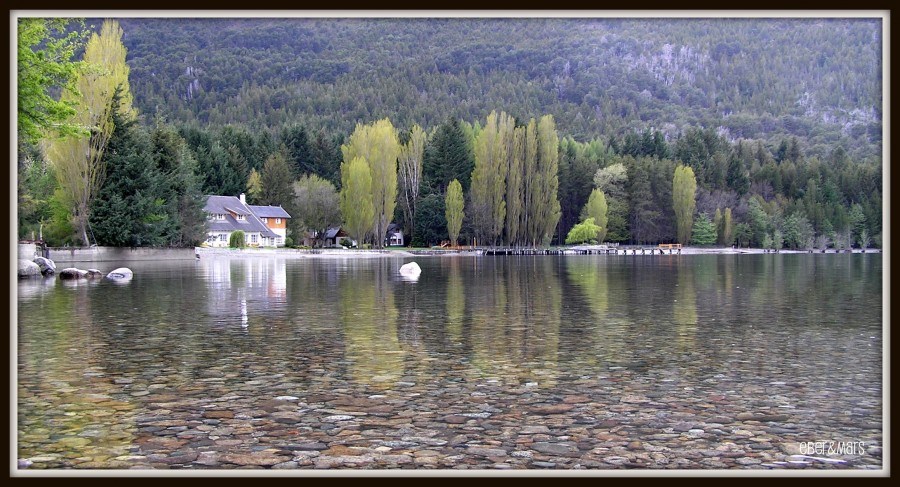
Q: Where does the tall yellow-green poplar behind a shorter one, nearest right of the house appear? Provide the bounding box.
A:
[341,118,400,248]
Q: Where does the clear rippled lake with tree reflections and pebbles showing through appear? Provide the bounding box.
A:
[15,254,884,471]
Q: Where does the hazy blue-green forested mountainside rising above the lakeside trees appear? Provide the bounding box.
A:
[116,18,882,157]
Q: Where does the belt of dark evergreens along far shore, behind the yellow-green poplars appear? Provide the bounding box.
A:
[19,111,883,252]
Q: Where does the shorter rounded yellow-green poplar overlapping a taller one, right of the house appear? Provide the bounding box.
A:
[341,157,375,246]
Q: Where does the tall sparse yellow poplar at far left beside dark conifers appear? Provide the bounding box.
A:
[47,20,134,245]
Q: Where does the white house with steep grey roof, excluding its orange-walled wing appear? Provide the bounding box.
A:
[203,193,284,247]
